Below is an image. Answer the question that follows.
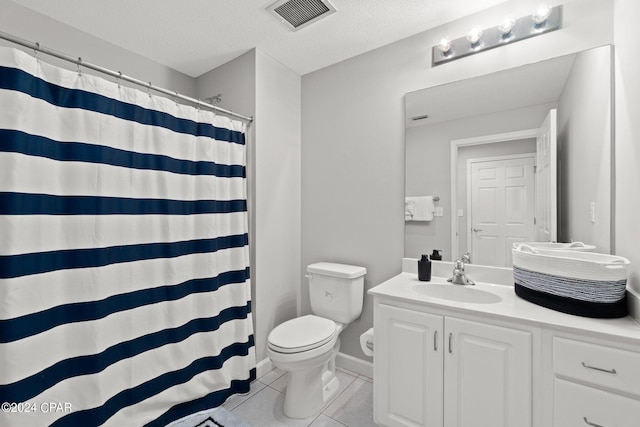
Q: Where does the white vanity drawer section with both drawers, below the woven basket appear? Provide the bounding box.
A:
[546,335,640,427]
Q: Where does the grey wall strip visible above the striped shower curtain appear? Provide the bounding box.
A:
[0,0,195,96]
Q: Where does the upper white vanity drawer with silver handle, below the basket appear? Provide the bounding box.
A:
[553,337,640,396]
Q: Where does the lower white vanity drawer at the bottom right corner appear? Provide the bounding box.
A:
[553,378,640,427]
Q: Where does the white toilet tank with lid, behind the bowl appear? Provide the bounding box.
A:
[307,262,367,324]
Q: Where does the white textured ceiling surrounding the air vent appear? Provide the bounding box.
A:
[13,0,507,77]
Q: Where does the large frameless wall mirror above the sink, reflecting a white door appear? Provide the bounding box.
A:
[405,46,613,267]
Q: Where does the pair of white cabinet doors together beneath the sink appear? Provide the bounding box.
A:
[374,301,532,427]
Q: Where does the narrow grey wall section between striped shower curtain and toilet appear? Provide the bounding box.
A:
[254,51,301,361]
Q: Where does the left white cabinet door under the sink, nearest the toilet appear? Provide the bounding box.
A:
[373,304,443,427]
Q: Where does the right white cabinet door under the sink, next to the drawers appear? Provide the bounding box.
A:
[444,317,532,427]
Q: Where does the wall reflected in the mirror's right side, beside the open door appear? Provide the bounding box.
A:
[558,49,612,253]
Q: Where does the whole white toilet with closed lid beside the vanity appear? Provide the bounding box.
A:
[267,262,367,418]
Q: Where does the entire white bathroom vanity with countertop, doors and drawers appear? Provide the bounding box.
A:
[368,268,640,427]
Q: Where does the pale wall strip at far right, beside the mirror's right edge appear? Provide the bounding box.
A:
[614,0,640,315]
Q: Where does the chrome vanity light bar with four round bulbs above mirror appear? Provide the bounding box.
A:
[431,5,562,67]
